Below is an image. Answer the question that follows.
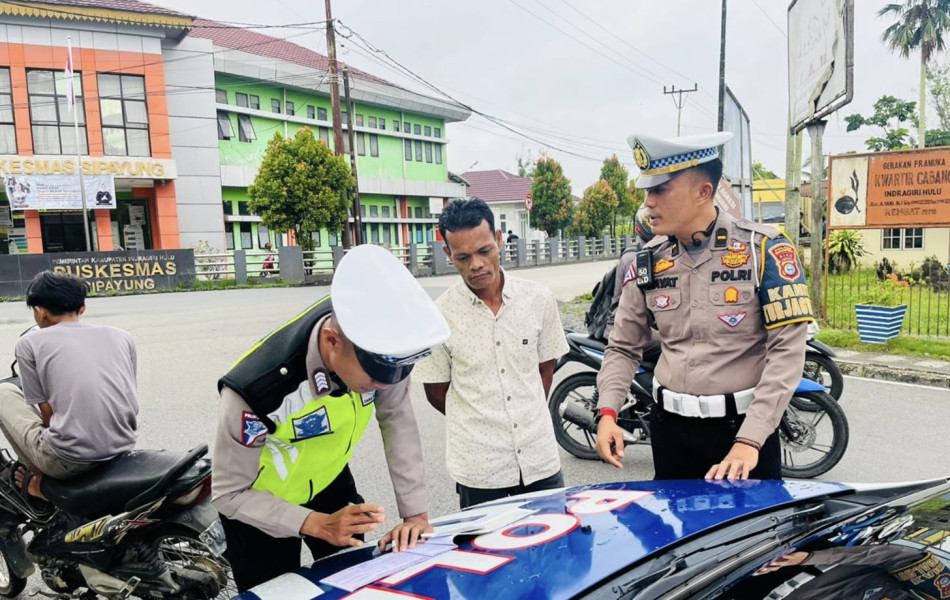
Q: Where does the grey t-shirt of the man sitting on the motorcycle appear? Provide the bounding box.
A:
[16,321,139,461]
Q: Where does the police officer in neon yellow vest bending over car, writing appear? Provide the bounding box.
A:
[213,246,449,591]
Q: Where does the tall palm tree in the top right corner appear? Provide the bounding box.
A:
[877,0,950,148]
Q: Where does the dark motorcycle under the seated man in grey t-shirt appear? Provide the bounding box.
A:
[0,379,237,600]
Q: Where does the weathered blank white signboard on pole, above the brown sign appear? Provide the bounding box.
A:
[788,0,854,133]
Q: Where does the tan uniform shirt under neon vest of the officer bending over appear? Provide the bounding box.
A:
[212,319,427,537]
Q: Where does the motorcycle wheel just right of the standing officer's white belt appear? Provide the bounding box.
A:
[779,392,850,479]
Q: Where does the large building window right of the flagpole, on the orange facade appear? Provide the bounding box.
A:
[98,73,150,156]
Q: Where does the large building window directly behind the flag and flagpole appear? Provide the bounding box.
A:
[26,71,89,155]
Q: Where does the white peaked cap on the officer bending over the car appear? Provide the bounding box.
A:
[330,245,450,384]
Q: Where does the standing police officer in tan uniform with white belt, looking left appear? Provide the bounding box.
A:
[597,133,813,479]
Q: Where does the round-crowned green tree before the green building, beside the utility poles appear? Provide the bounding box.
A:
[247,128,356,250]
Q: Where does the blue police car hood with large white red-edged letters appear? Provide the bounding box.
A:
[239,481,853,600]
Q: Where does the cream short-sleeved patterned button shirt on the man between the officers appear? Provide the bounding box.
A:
[412,273,568,489]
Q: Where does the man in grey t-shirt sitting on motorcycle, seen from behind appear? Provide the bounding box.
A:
[0,271,139,503]
